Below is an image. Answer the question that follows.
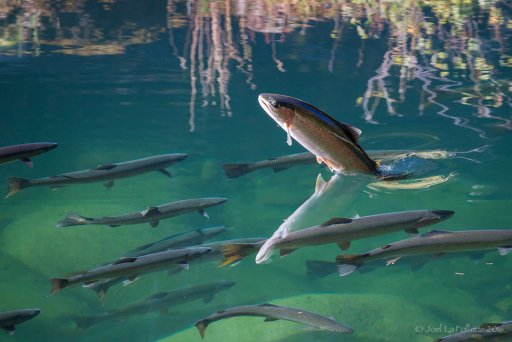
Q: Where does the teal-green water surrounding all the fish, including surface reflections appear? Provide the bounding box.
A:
[0,0,512,341]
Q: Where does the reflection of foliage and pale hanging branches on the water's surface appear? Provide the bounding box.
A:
[4,0,512,131]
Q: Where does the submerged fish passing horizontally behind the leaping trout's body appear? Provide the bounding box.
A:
[222,150,455,178]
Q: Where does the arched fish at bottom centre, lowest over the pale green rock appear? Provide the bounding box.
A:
[194,303,352,337]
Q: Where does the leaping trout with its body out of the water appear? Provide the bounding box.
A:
[258,94,396,178]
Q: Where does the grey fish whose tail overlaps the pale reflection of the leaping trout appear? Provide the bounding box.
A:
[250,210,454,257]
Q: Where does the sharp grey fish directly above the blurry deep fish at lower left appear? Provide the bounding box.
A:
[50,247,211,295]
